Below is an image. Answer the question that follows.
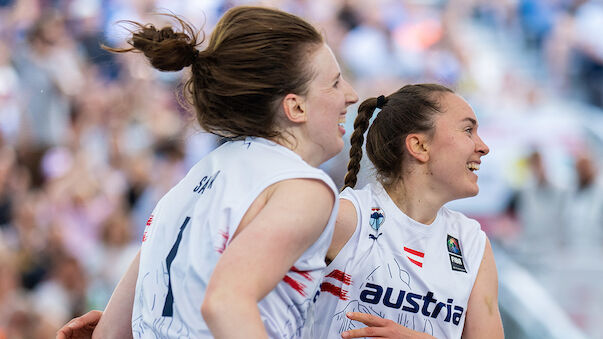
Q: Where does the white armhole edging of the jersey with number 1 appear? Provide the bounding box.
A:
[227,171,339,246]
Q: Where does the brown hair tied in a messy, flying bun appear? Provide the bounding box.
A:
[109,6,324,137]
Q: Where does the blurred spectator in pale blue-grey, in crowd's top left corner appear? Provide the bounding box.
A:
[13,11,82,147]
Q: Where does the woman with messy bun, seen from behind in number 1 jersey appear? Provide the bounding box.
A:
[57,6,358,338]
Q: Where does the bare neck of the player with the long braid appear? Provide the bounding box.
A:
[385,173,444,225]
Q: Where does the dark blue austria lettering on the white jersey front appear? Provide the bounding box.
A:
[360,282,465,326]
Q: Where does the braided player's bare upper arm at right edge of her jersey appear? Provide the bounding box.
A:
[463,238,504,339]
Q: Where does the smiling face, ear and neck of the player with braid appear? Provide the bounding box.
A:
[385,93,490,225]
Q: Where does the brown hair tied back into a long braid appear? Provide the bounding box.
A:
[343,84,454,188]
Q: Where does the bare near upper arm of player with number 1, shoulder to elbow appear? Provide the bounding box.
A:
[206,179,335,303]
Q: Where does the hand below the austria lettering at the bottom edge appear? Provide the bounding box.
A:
[341,312,434,339]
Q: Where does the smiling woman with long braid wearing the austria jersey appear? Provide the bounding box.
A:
[313,84,503,339]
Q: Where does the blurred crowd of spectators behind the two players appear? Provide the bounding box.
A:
[0,0,603,339]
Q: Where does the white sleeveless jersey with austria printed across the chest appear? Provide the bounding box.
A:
[313,184,486,339]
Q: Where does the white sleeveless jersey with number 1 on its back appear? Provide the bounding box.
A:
[132,138,338,338]
